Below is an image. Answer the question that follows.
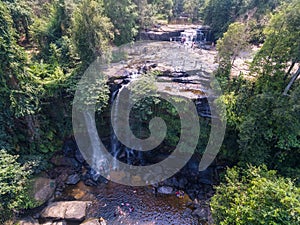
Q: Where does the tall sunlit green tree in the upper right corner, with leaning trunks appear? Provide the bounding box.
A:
[253,1,300,93]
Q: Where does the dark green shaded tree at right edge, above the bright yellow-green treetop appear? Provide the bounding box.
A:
[239,88,300,176]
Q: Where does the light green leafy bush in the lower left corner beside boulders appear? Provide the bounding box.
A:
[0,150,32,222]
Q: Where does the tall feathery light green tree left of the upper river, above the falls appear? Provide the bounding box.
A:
[72,0,113,64]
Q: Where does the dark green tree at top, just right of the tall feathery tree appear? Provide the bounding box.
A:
[104,0,138,45]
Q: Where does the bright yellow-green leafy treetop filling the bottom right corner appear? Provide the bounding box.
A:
[211,166,300,225]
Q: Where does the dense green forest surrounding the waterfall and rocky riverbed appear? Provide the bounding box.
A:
[0,0,300,224]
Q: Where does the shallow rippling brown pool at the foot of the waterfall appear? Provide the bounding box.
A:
[65,182,200,225]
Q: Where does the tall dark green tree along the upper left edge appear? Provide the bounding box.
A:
[0,2,25,149]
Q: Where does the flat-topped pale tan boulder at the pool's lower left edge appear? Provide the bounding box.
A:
[41,201,91,221]
